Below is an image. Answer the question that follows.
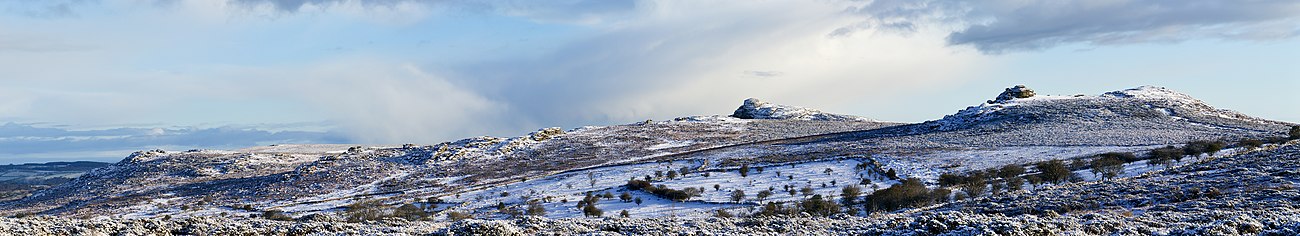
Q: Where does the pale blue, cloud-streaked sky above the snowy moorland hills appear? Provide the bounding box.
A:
[0,0,1300,163]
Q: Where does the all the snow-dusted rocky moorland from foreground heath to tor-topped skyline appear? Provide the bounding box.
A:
[0,86,1300,235]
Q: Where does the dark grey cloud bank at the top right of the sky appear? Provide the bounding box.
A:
[835,0,1300,53]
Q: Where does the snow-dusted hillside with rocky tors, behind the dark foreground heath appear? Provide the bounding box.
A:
[0,87,1294,234]
